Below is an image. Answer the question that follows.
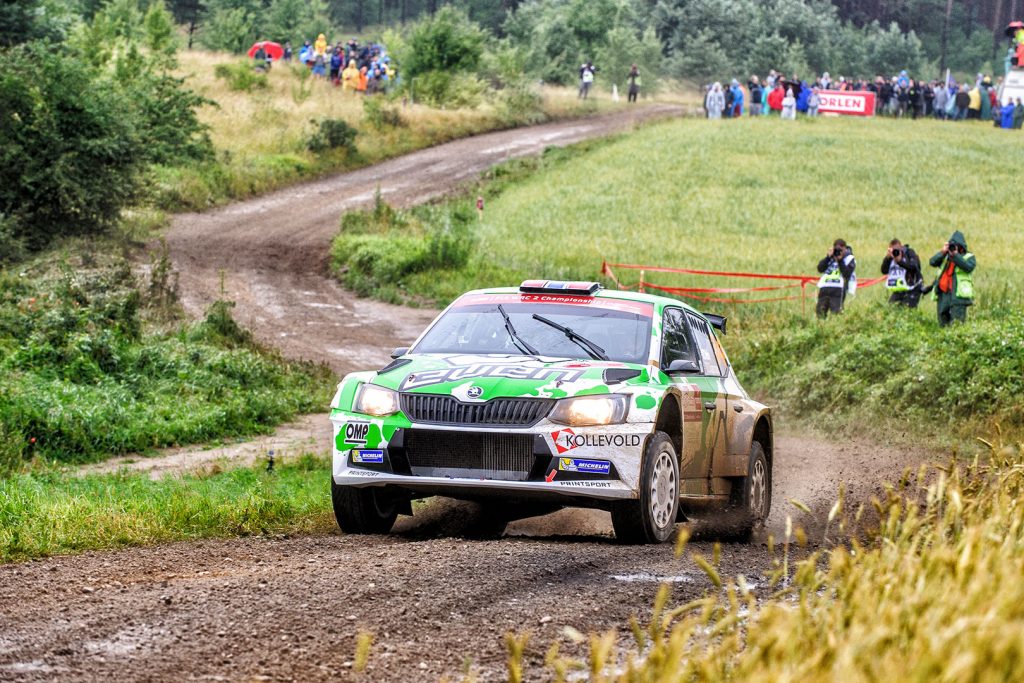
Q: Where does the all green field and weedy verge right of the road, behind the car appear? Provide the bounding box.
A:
[333,118,1024,444]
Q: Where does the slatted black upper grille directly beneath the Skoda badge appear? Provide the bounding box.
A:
[400,393,555,427]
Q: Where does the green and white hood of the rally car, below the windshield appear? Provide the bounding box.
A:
[371,353,650,401]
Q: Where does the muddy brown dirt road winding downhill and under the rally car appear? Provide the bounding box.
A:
[0,109,926,681]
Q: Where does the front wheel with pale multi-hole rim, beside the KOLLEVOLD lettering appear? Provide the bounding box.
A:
[611,432,679,544]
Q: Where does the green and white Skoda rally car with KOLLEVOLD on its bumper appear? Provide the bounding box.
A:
[331,281,772,543]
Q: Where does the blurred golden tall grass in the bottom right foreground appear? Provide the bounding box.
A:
[513,436,1024,681]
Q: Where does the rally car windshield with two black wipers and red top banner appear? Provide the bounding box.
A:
[414,301,651,364]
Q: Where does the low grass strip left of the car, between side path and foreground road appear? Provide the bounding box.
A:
[0,456,334,562]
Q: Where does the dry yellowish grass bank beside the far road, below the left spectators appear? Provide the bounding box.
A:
[153,51,624,210]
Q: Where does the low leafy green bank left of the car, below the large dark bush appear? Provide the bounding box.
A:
[0,253,331,462]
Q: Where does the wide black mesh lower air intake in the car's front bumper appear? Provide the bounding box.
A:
[404,429,537,481]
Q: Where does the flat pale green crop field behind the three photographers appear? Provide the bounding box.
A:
[410,118,1024,300]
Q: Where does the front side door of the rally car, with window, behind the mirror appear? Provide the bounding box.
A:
[662,306,708,496]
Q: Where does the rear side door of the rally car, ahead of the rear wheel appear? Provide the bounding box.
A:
[684,312,729,493]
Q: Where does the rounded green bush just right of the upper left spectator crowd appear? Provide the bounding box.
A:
[398,5,486,80]
